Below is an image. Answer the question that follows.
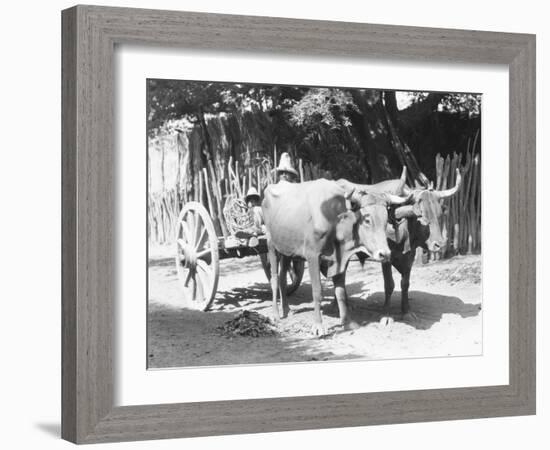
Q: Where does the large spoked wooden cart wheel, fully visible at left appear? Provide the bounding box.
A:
[176,202,219,311]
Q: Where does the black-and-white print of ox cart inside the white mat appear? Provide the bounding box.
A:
[146,79,483,369]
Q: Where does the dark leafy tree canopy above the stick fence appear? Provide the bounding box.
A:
[147,79,481,183]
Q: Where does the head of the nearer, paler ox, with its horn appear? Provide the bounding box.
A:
[336,187,410,261]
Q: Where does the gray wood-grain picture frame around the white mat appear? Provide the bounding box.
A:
[62,6,536,443]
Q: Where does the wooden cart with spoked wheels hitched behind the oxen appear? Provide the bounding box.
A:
[176,202,304,311]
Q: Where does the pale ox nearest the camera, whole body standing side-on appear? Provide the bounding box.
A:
[262,179,407,334]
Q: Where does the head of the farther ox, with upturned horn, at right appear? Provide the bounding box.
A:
[395,169,461,252]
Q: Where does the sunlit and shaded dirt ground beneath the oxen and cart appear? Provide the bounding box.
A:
[147,246,482,368]
